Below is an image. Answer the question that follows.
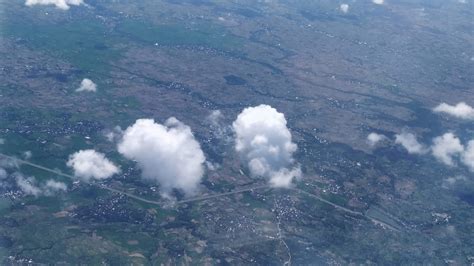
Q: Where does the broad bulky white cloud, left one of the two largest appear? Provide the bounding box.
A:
[118,117,206,196]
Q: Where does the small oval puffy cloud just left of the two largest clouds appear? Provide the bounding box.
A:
[67,150,120,181]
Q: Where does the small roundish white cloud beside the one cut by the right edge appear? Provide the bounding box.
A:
[431,133,464,166]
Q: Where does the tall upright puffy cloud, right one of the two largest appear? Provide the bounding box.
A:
[233,105,301,187]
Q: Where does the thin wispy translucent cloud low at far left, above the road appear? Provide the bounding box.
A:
[15,173,67,197]
